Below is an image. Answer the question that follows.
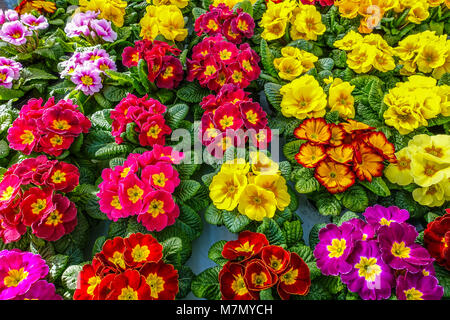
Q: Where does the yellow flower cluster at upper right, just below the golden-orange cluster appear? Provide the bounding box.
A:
[334,30,395,73]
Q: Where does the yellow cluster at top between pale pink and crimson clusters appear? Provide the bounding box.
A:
[140,4,188,41]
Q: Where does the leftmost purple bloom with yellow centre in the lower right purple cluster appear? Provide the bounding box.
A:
[314,222,362,276]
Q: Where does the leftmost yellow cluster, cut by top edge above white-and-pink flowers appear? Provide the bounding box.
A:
[79,0,127,27]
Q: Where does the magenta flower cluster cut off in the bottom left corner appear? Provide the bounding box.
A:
[0,249,62,300]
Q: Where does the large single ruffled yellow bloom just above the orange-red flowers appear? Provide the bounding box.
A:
[280,75,327,120]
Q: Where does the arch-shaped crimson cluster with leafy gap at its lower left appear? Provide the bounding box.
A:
[111,93,172,146]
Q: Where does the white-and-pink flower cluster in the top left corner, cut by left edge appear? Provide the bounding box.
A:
[0,10,48,46]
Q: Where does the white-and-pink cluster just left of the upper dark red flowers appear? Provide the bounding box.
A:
[61,47,117,95]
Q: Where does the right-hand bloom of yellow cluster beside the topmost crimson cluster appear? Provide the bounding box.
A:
[158,5,188,41]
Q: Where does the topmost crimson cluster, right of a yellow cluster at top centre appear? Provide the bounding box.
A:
[195,3,255,43]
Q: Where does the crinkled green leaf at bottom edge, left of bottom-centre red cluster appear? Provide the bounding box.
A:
[191,266,222,300]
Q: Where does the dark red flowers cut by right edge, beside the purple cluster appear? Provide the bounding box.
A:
[423,209,450,271]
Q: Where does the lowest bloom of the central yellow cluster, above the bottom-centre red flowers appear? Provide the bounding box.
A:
[238,184,277,221]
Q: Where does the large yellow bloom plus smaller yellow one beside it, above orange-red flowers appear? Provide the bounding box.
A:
[280,74,355,120]
